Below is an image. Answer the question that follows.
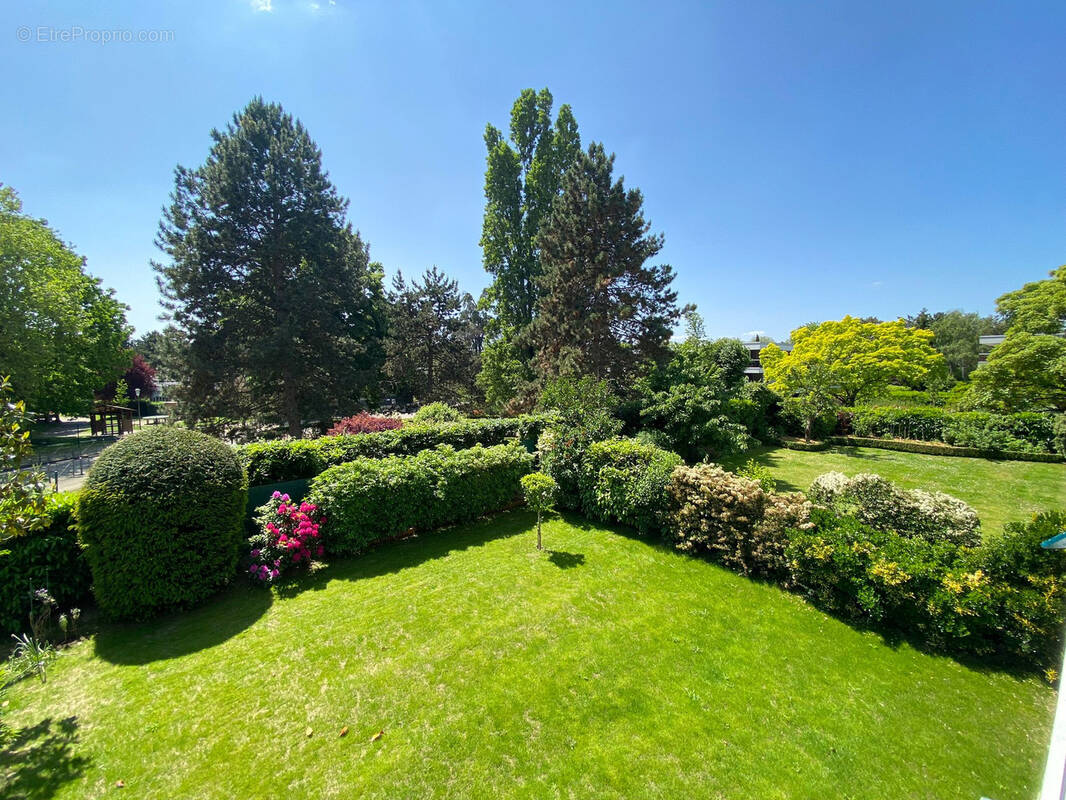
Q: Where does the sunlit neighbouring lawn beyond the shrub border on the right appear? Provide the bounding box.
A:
[723,447,1066,533]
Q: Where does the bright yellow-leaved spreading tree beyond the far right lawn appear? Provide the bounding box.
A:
[759,317,947,405]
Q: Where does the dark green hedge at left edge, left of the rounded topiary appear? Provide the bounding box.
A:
[0,495,92,634]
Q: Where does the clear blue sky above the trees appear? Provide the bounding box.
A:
[0,0,1066,337]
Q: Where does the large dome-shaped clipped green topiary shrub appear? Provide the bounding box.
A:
[78,427,247,620]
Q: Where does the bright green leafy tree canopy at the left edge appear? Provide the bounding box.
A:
[0,186,130,414]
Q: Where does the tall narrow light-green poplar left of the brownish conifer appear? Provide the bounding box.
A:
[478,89,581,407]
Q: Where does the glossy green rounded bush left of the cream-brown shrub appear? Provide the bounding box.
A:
[580,438,682,533]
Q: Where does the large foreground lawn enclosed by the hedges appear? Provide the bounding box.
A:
[0,512,1055,800]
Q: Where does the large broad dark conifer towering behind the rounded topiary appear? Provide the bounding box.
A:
[155,98,385,436]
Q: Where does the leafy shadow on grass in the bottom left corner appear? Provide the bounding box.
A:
[0,717,91,800]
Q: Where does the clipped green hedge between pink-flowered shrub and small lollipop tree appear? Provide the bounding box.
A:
[308,444,533,554]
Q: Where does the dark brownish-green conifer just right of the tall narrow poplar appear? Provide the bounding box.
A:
[533,143,680,386]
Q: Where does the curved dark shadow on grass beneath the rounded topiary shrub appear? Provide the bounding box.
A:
[94,577,273,665]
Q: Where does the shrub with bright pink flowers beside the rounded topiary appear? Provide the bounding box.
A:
[248,492,324,585]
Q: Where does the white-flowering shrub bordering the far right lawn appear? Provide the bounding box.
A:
[807,473,981,547]
